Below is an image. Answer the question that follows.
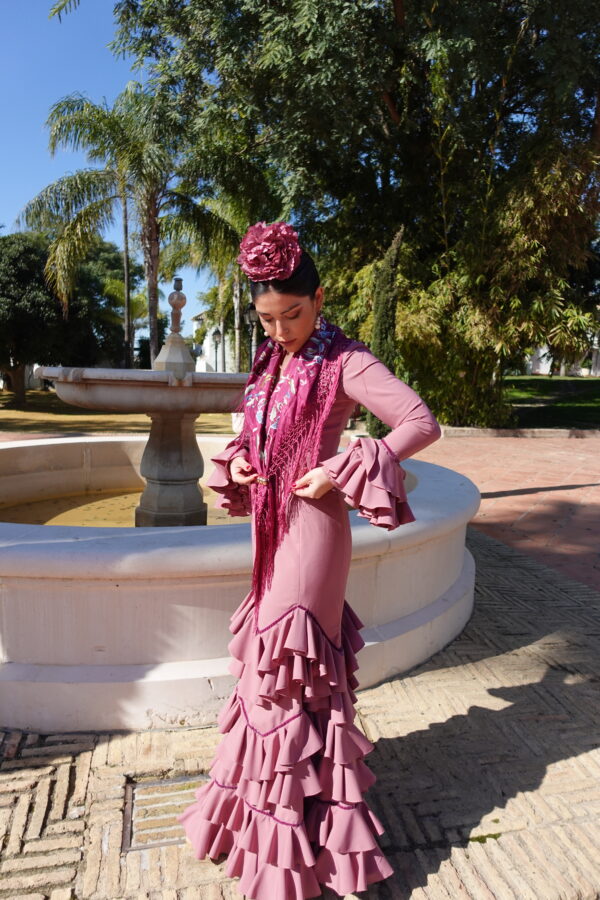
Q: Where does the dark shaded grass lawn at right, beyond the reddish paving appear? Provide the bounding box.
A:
[506,375,600,428]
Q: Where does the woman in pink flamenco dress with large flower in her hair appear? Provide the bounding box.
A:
[178,222,440,900]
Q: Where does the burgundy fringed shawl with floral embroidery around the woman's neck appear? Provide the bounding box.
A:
[238,317,350,604]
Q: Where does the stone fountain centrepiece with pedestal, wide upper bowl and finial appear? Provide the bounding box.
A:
[36,278,246,527]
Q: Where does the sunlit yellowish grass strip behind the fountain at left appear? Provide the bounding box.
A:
[0,391,232,436]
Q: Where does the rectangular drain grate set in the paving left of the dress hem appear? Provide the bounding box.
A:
[121,775,208,853]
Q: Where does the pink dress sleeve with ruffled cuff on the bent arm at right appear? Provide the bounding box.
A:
[321,347,441,529]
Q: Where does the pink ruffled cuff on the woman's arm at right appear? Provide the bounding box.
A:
[321,438,415,530]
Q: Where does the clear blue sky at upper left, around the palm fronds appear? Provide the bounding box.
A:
[0,0,210,332]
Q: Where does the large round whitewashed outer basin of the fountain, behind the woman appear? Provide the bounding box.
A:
[0,434,479,732]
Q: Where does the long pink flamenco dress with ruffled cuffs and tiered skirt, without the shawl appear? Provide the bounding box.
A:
[178,342,440,900]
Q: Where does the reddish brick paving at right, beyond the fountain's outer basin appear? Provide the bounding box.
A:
[417,437,600,590]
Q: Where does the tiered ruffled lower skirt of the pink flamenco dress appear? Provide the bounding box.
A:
[178,595,393,900]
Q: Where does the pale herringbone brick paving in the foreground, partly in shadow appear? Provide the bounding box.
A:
[0,530,600,900]
